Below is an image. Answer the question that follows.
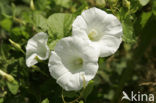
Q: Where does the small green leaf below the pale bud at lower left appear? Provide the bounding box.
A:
[7,80,19,95]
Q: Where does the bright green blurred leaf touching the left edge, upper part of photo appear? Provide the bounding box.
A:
[0,19,12,31]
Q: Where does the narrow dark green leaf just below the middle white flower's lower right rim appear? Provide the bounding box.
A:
[82,80,94,99]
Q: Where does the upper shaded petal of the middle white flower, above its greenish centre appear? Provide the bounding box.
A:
[55,36,98,68]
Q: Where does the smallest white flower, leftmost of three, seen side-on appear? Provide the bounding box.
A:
[26,32,49,67]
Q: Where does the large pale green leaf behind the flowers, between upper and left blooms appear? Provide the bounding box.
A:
[47,13,74,38]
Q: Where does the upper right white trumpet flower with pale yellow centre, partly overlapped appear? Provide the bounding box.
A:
[72,7,123,57]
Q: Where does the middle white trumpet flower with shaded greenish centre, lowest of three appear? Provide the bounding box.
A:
[48,37,98,91]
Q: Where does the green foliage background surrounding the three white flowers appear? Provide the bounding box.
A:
[0,0,156,103]
